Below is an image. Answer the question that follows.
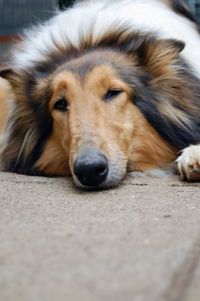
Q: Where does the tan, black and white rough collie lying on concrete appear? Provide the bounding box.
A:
[0,0,200,189]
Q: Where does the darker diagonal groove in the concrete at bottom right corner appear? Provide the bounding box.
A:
[159,239,200,301]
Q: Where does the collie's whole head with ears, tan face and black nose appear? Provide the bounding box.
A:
[1,35,194,188]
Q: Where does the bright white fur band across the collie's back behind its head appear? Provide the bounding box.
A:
[12,0,200,77]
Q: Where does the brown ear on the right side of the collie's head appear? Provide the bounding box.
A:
[136,38,185,76]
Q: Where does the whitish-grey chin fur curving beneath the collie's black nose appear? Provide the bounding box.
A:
[72,161,126,191]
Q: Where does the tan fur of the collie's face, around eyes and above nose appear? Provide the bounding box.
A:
[36,65,176,175]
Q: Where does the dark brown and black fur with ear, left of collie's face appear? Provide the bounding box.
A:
[1,70,51,174]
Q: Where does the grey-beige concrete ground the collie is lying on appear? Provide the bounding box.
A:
[0,173,200,301]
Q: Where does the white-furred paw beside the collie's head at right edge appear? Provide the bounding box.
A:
[176,145,200,181]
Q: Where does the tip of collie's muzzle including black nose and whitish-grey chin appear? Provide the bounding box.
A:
[72,149,126,190]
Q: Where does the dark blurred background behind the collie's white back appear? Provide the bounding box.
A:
[0,0,200,62]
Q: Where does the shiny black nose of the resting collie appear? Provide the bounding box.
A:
[74,149,109,187]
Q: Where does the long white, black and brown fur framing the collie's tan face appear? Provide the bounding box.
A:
[0,0,200,184]
